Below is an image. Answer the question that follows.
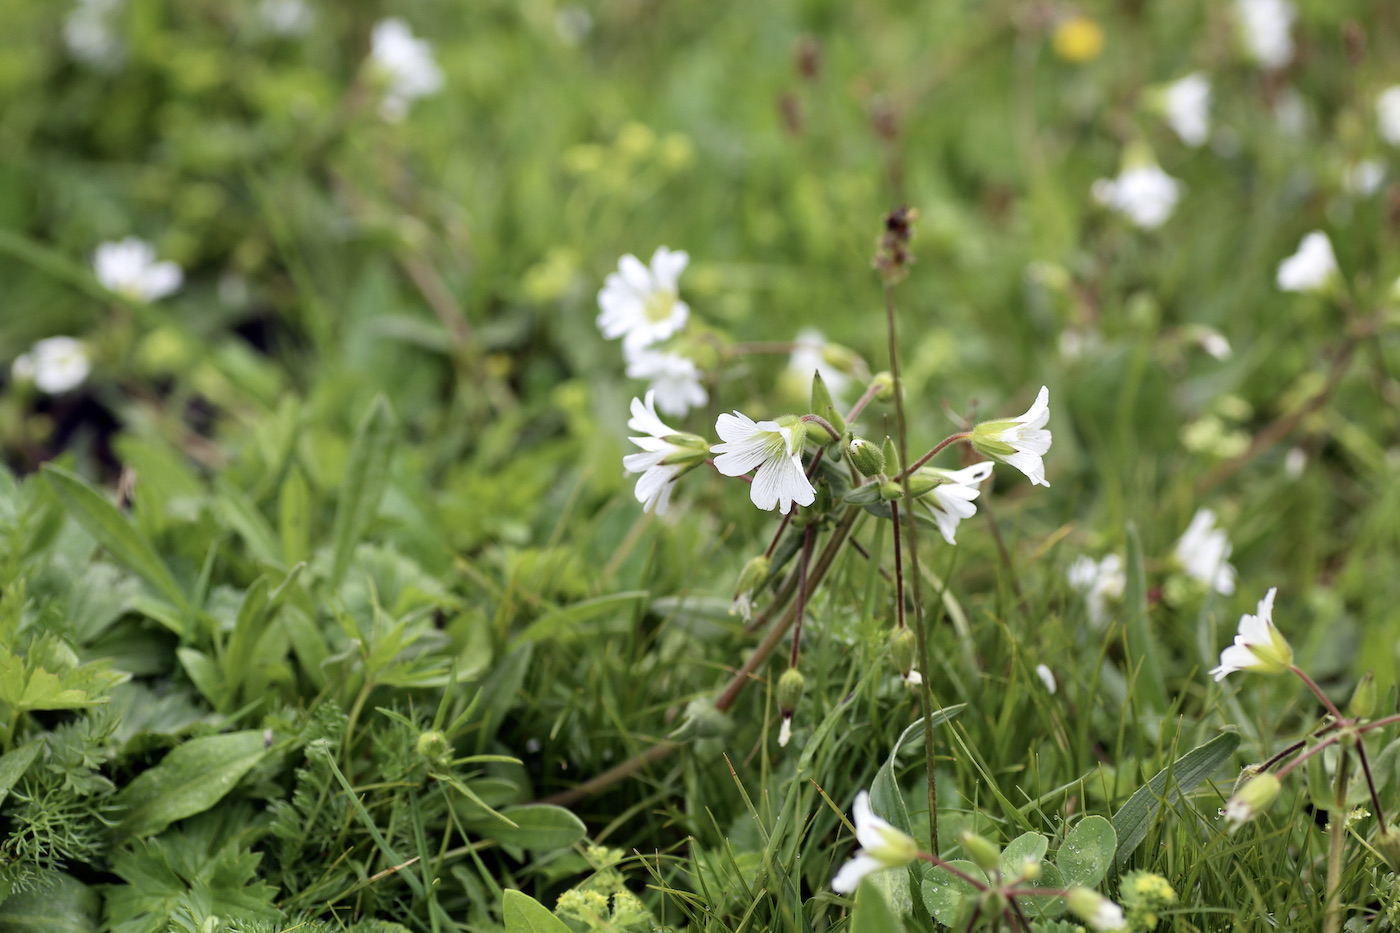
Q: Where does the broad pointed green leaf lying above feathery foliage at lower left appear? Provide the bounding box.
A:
[115,730,267,839]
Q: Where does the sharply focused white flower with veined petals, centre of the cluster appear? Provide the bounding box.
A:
[710,412,816,514]
